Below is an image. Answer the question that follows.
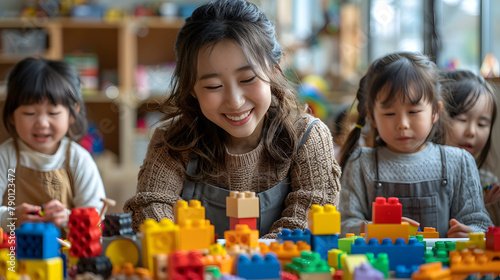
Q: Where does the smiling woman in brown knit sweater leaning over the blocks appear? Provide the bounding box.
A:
[124,0,340,238]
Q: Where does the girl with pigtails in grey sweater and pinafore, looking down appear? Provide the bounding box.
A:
[340,53,491,237]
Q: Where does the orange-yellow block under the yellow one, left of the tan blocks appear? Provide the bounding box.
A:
[177,220,215,250]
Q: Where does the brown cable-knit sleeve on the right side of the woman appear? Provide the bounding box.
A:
[264,118,341,238]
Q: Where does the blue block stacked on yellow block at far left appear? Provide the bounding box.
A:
[16,223,61,260]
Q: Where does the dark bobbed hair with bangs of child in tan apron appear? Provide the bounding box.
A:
[3,57,87,140]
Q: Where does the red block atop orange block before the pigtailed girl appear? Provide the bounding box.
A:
[372,197,403,224]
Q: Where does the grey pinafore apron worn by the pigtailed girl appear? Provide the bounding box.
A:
[375,146,451,237]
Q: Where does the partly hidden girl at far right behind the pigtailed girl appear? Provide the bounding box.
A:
[441,70,500,226]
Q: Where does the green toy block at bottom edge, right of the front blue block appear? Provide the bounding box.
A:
[284,251,332,280]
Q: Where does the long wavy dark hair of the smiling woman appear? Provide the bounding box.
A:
[160,0,300,181]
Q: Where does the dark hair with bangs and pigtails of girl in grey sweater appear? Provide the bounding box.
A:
[340,52,448,168]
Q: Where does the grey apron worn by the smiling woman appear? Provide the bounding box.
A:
[181,119,318,238]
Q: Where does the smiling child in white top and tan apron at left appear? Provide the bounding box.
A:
[0,58,105,232]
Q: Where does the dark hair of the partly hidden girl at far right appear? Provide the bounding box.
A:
[440,70,497,168]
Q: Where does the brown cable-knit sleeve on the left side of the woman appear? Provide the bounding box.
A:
[123,128,189,232]
